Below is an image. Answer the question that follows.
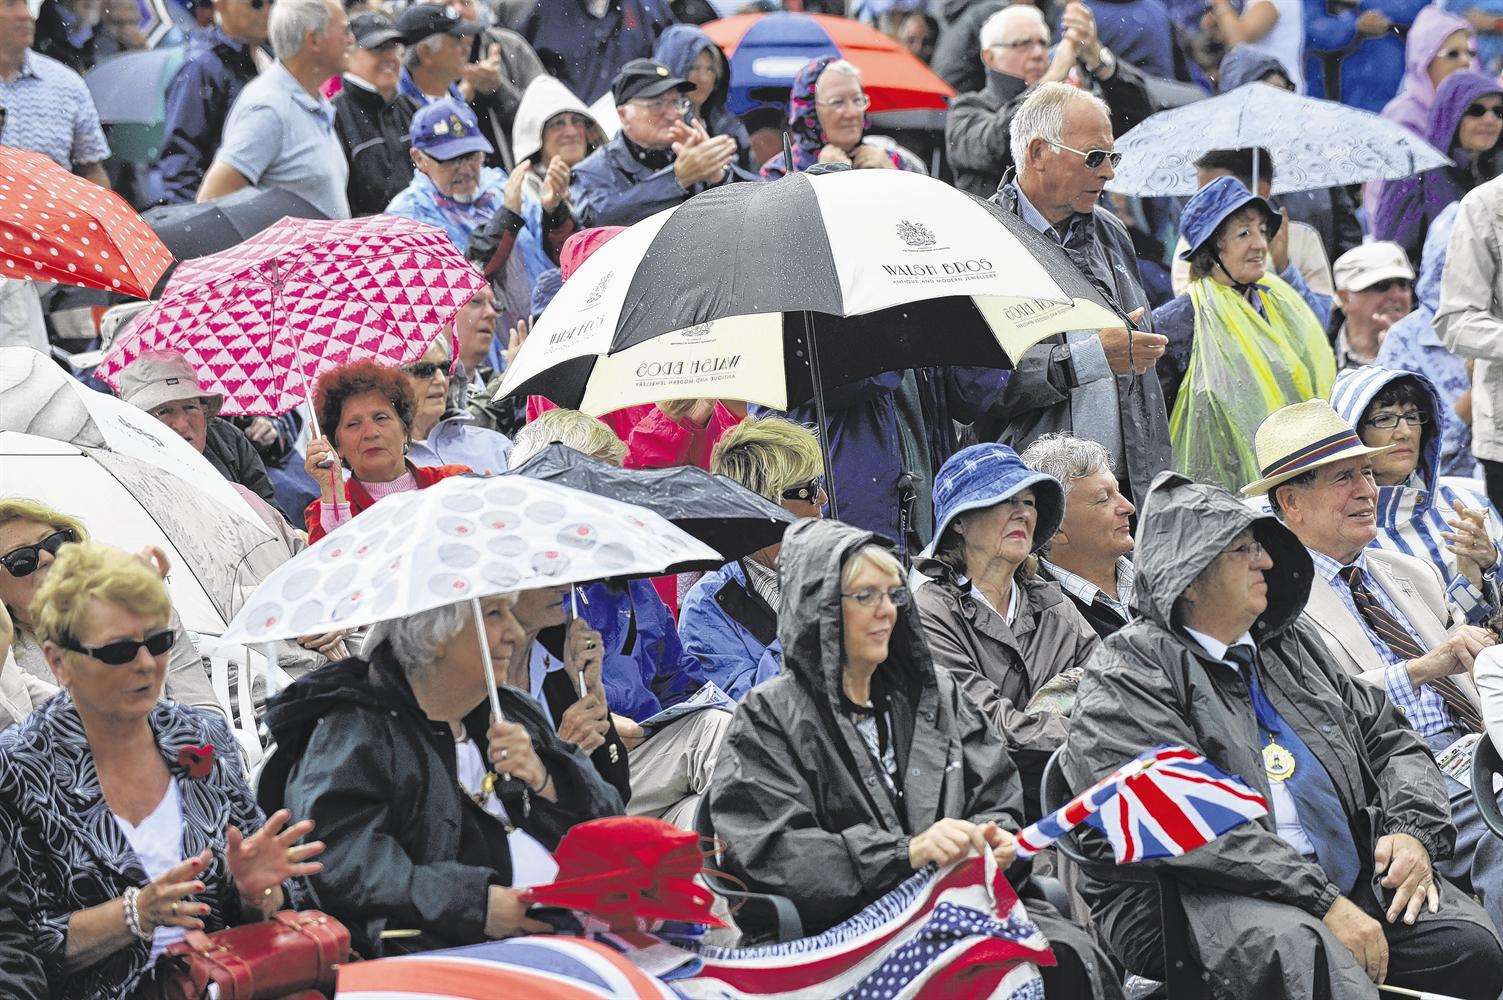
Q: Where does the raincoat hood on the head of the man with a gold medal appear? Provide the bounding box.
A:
[1133,472,1314,642]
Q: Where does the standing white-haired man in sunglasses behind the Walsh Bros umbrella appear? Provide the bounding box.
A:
[992,83,1172,505]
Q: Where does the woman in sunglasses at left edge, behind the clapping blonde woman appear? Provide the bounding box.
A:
[0,499,219,729]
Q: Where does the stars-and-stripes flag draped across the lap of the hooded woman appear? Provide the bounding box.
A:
[640,854,1054,1000]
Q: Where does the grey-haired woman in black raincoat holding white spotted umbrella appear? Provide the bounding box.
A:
[260,595,622,956]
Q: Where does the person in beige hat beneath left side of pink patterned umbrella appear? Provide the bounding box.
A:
[120,350,277,504]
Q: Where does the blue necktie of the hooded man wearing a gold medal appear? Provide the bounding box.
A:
[1226,645,1362,893]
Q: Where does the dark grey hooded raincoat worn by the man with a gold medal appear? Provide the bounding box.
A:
[1064,472,1486,1000]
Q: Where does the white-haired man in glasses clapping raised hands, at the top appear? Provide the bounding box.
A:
[944,3,1153,198]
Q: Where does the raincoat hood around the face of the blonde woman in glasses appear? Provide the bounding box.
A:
[777,519,935,713]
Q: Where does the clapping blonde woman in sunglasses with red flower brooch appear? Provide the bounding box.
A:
[0,541,323,1000]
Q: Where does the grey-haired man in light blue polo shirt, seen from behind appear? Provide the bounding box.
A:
[198,0,353,218]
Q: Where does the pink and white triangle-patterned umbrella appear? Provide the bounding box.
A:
[99,215,485,415]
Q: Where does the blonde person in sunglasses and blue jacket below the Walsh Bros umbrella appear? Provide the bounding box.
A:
[678,417,828,699]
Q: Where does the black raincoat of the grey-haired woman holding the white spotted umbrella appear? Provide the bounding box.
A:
[257,644,622,956]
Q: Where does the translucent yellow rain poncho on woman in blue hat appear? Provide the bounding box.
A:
[1169,274,1336,492]
